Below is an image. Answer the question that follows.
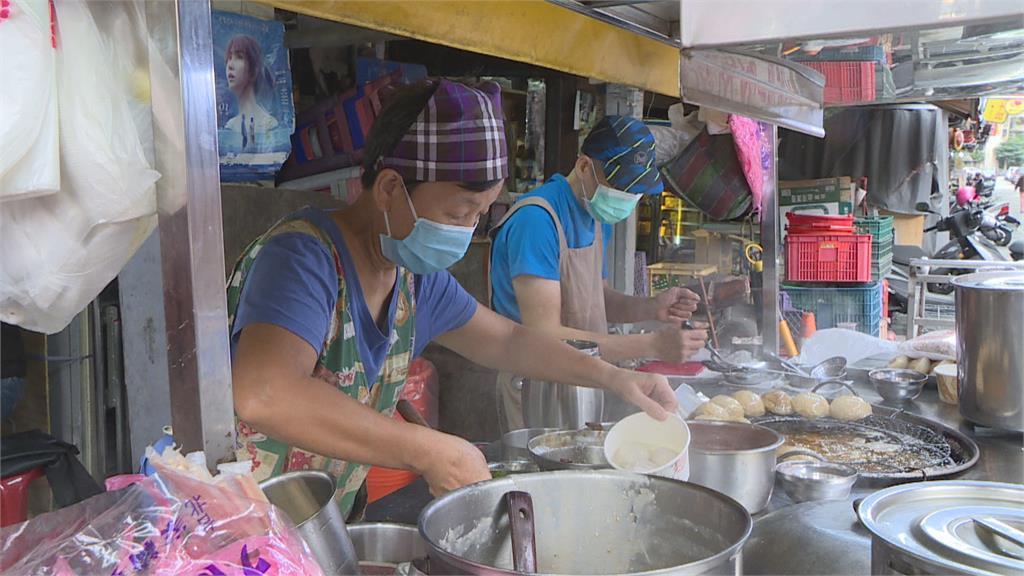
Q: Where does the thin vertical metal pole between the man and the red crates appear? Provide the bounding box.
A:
[761,124,780,353]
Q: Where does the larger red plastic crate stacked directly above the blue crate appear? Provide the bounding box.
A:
[785,233,871,283]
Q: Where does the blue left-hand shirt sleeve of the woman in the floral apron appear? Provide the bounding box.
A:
[231,233,338,355]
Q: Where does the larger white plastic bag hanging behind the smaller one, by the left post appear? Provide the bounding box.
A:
[0,0,160,333]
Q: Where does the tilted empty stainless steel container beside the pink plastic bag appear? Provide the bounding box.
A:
[259,470,359,574]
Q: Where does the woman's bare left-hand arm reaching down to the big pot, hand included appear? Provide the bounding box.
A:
[231,324,490,493]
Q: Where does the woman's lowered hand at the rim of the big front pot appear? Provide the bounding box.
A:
[420,433,490,496]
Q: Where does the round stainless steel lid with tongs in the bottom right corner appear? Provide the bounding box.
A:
[857,481,1024,574]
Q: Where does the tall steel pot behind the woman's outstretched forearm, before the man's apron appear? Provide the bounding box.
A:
[522,340,604,429]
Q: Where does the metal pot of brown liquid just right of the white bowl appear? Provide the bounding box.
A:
[686,420,784,513]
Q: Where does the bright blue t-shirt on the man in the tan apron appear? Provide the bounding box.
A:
[490,174,611,322]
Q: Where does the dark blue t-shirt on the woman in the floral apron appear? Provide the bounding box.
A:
[231,208,476,385]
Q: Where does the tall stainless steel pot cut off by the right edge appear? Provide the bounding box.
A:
[952,271,1024,431]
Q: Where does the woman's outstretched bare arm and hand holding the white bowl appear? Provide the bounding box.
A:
[436,306,677,420]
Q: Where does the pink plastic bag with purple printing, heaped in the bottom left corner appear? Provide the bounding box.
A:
[0,461,323,576]
